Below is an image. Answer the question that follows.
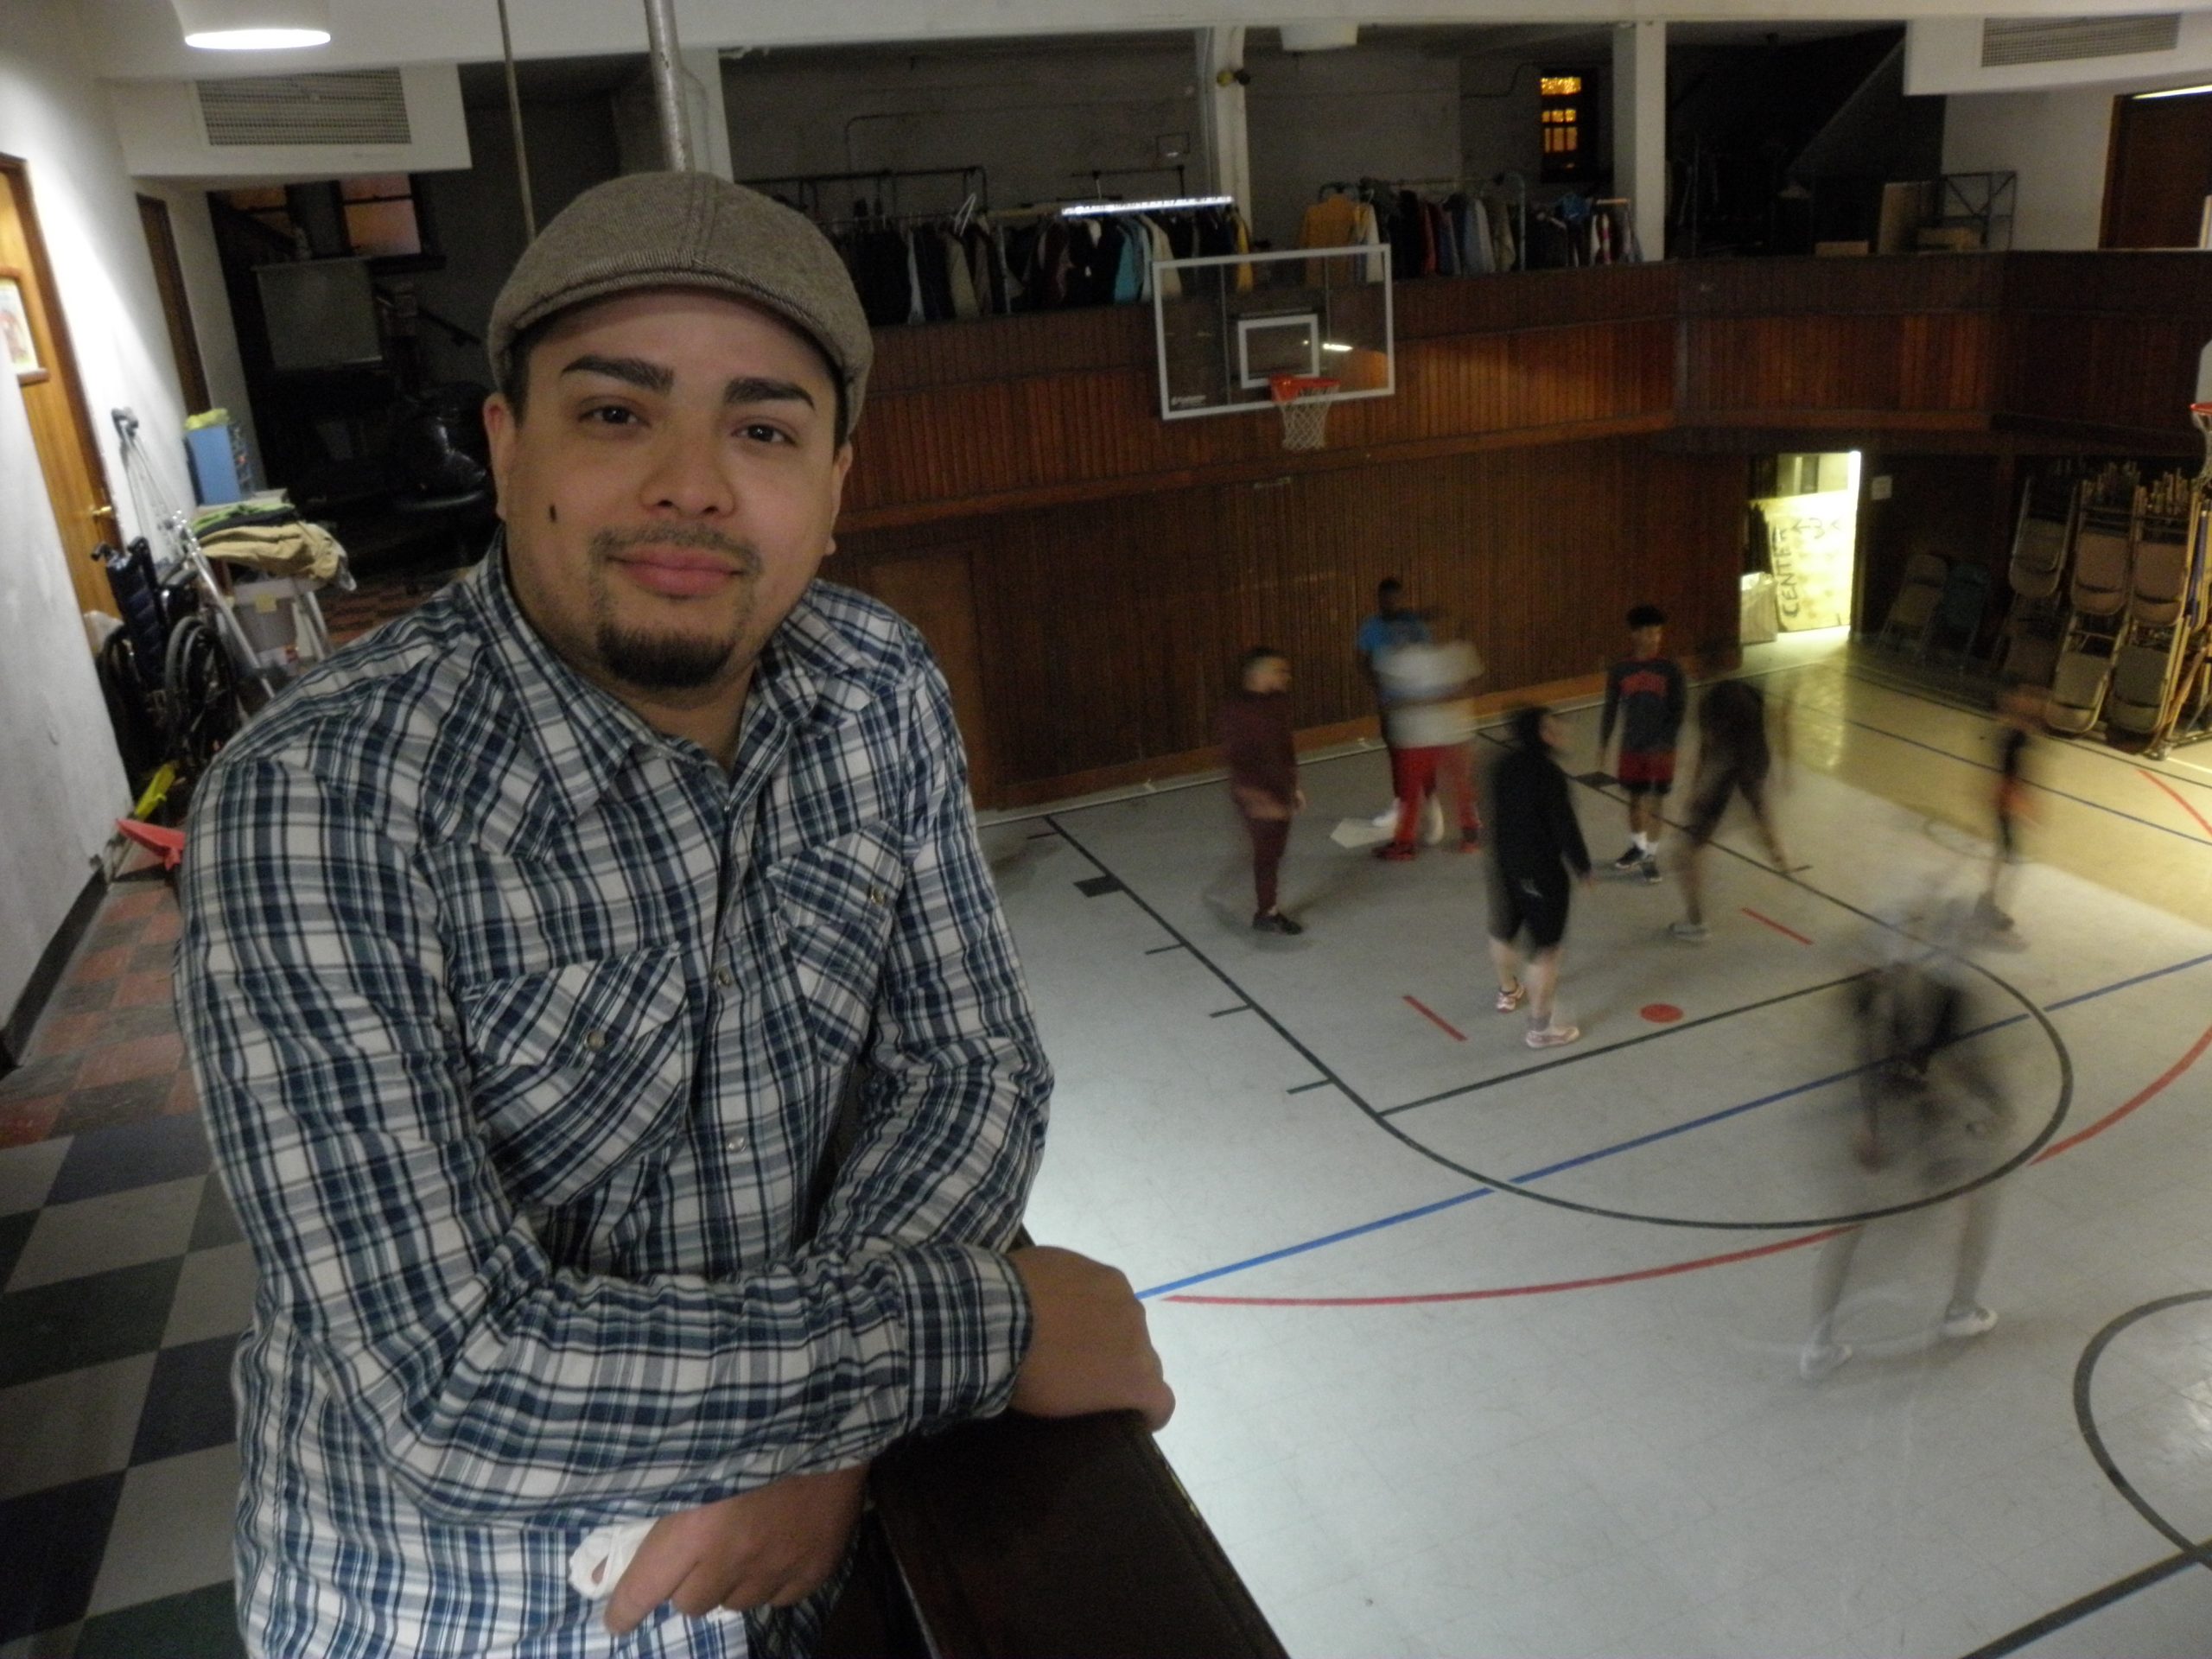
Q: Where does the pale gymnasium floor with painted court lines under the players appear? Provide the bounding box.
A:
[1004,639,2212,1659]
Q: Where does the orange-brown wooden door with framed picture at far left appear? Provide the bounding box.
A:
[0,155,118,628]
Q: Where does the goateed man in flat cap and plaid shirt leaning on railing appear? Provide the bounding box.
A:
[179,173,1173,1659]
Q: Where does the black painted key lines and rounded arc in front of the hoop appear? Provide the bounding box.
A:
[1046,800,2075,1232]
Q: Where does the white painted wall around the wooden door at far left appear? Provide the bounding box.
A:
[0,0,186,1011]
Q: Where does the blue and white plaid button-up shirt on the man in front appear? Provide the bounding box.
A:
[177,549,1051,1659]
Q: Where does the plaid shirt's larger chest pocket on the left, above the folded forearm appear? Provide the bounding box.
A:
[458,949,692,1205]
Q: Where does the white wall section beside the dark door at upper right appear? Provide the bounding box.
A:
[1942,86,2114,248]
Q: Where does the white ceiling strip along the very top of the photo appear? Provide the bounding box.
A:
[78,0,2212,79]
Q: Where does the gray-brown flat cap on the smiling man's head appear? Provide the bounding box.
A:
[485,173,876,429]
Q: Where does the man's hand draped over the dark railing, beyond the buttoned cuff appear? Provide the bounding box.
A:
[1008,1245,1174,1433]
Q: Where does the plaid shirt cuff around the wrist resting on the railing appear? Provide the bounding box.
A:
[892,1243,1033,1429]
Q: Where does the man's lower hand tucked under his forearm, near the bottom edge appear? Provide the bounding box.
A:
[606,1465,868,1637]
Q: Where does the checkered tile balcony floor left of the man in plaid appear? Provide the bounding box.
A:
[0,880,252,1659]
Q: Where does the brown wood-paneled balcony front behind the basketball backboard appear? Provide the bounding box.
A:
[845,252,2212,531]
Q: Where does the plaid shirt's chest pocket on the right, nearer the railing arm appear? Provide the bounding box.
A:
[767,823,907,1059]
